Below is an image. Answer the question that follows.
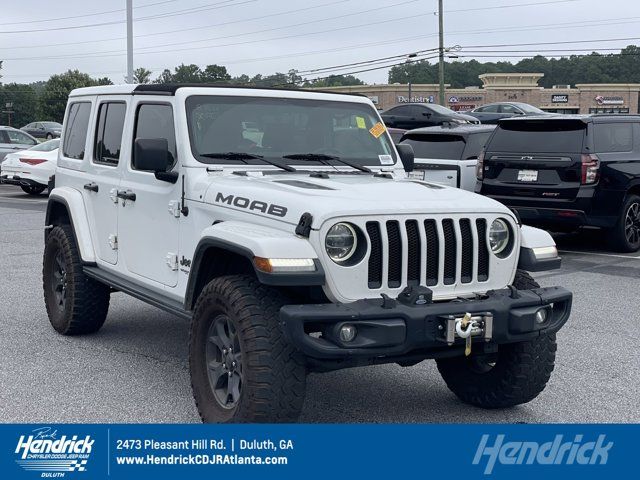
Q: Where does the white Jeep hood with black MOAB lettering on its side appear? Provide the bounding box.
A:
[203,172,512,228]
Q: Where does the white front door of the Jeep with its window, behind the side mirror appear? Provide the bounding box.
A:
[118,99,181,287]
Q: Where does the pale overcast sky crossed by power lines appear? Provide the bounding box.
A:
[0,0,640,83]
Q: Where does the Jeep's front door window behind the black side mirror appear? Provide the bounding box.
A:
[131,103,177,170]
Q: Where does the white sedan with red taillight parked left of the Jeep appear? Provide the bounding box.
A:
[0,138,60,195]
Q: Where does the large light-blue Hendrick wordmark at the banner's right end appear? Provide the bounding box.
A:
[473,435,613,475]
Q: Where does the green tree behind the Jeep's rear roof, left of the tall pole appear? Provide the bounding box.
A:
[40,70,111,122]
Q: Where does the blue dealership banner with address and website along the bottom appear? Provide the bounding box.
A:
[0,424,640,480]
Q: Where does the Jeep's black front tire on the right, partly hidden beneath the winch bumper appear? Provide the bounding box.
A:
[436,270,557,408]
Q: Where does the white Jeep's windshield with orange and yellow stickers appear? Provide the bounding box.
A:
[186,95,396,166]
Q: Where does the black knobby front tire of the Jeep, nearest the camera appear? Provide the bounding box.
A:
[189,275,306,423]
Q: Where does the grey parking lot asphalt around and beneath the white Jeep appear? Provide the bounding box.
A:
[0,186,640,423]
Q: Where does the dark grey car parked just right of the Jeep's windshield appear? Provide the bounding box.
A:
[382,103,480,130]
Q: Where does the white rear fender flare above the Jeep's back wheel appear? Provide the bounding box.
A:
[45,187,96,264]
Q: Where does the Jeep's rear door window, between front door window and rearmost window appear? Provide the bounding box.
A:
[93,102,127,166]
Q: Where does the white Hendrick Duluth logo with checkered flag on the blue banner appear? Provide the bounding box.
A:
[14,427,94,478]
